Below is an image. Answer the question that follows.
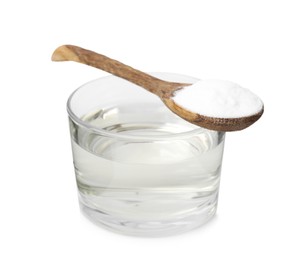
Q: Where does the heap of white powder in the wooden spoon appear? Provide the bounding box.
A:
[173,79,263,118]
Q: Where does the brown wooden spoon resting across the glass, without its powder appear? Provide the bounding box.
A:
[52,45,263,132]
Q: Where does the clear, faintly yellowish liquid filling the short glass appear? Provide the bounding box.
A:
[71,106,224,235]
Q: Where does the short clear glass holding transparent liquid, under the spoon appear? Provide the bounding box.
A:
[67,73,225,236]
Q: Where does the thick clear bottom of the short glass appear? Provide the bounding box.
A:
[79,192,218,237]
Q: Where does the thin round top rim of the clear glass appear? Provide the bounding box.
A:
[67,72,218,141]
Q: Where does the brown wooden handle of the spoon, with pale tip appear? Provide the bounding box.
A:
[52,45,188,98]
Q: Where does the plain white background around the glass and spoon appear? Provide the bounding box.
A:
[0,0,300,260]
